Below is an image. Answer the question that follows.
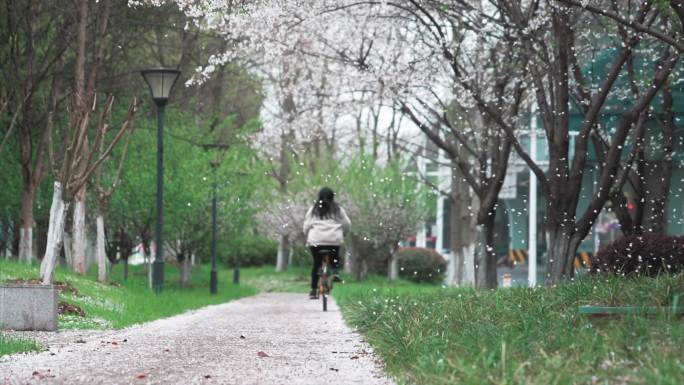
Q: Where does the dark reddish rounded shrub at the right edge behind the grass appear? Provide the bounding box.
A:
[592,233,684,275]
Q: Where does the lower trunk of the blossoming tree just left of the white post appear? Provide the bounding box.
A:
[475,215,498,289]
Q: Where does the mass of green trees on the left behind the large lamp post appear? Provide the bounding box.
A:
[0,0,267,282]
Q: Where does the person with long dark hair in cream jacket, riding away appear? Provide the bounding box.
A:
[303,187,351,299]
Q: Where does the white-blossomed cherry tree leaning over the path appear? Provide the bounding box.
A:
[148,1,508,287]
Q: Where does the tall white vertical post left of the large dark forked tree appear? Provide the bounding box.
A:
[527,105,537,287]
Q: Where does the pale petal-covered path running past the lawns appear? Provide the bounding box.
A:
[0,293,393,385]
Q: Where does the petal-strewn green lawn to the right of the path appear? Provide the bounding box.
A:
[333,276,684,385]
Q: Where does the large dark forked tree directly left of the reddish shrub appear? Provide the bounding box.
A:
[484,1,678,283]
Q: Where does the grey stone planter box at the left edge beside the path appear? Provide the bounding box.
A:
[0,284,59,331]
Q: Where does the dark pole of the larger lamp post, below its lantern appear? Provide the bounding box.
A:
[152,103,165,293]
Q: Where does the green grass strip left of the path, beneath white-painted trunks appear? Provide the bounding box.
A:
[0,260,257,329]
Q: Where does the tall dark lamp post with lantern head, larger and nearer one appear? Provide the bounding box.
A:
[141,68,180,293]
